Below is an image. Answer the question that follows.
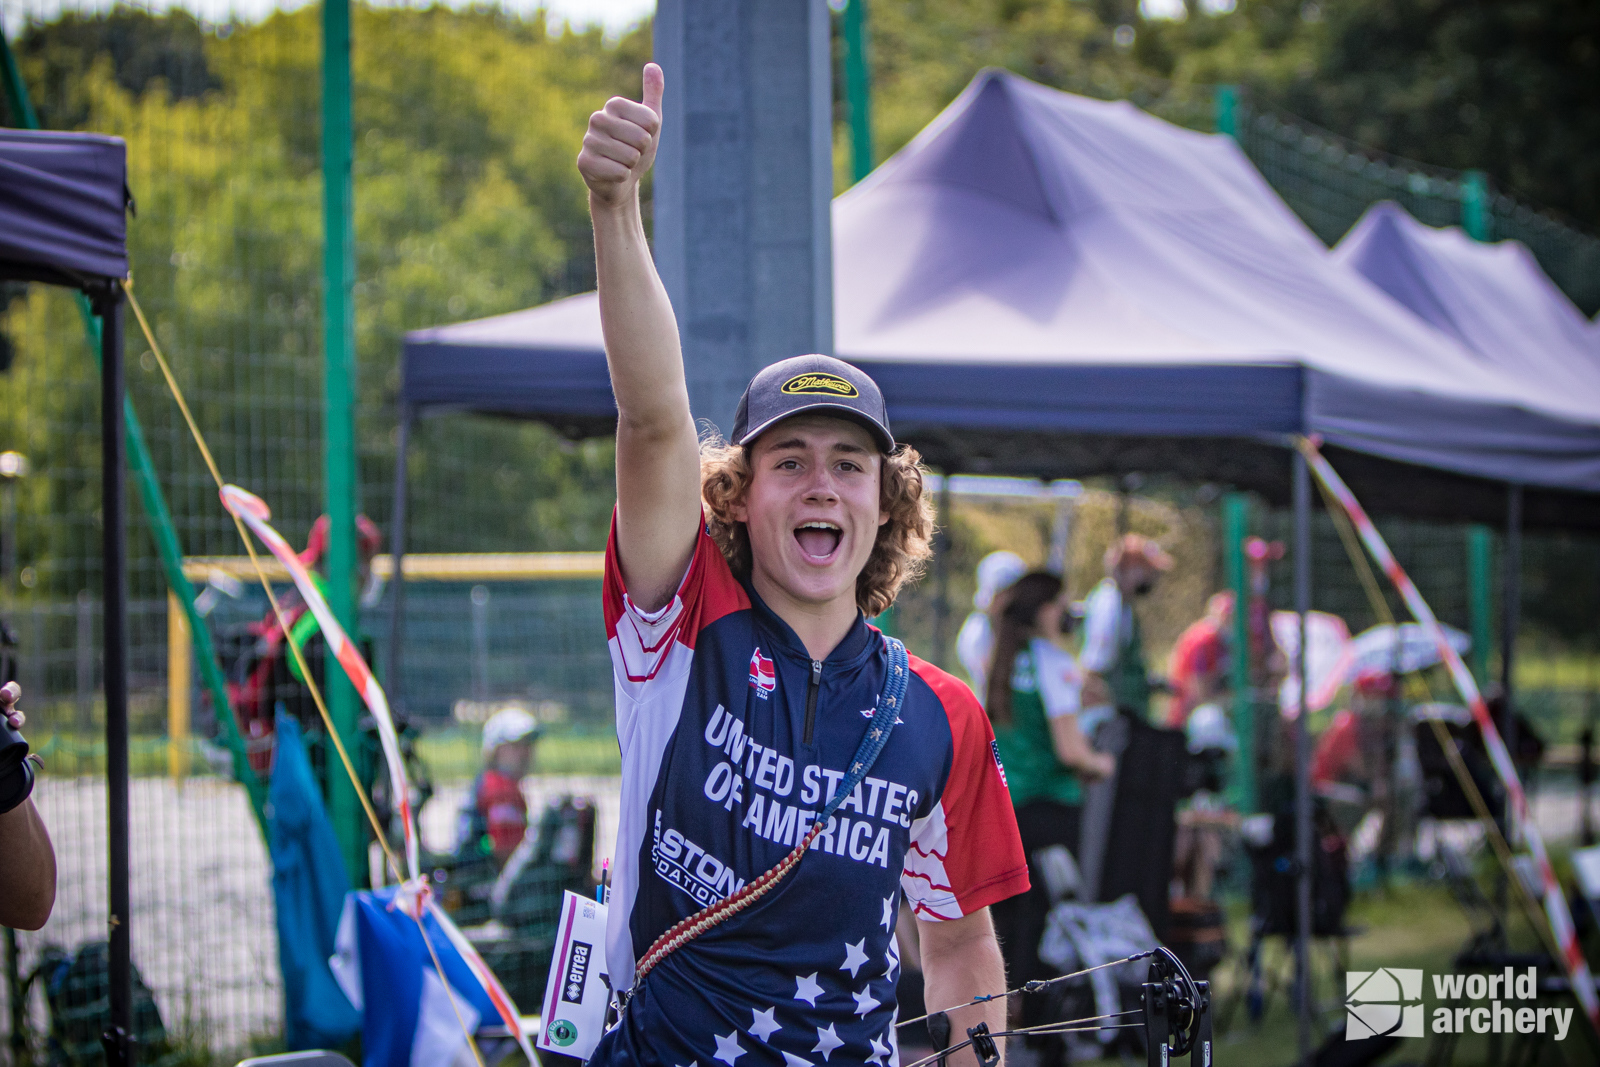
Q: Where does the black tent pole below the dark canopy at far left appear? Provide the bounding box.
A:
[93,282,133,1067]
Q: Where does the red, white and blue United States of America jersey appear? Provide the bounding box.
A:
[605,537,1026,1067]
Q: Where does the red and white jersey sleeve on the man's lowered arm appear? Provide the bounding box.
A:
[902,656,1029,920]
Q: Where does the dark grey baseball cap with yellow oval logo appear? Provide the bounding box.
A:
[733,355,894,454]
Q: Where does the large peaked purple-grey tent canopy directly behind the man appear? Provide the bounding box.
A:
[402,70,1600,491]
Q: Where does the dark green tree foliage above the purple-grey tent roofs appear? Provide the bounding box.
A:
[840,0,1600,232]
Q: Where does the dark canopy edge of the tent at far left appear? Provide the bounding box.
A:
[0,130,130,285]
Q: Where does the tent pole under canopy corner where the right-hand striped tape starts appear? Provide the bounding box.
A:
[1294,450,1312,1067]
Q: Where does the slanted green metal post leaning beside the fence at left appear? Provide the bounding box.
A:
[0,22,266,829]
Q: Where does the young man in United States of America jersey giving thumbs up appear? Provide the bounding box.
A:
[578,64,1027,1067]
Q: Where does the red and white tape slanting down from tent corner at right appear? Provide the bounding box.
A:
[1301,438,1600,1029]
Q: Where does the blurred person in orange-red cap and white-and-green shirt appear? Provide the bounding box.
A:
[1082,534,1173,718]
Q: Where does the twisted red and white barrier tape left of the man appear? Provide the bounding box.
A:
[222,485,539,1064]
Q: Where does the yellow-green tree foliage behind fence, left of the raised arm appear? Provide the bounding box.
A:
[0,6,650,595]
